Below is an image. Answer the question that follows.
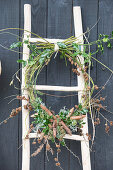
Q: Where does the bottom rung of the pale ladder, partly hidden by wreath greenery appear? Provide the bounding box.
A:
[29,133,84,141]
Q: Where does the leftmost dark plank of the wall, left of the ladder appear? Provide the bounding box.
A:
[0,0,19,170]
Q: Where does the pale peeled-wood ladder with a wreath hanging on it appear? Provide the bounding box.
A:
[22,4,91,170]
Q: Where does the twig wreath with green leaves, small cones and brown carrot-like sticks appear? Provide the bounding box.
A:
[1,29,113,167]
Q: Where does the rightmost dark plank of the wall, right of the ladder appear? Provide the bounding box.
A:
[95,0,113,170]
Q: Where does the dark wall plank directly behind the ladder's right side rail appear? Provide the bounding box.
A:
[70,0,98,170]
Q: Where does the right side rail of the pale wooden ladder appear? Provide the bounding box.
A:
[73,6,91,170]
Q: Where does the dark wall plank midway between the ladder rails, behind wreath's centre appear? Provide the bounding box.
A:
[45,0,72,170]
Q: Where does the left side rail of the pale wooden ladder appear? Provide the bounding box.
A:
[22,4,31,170]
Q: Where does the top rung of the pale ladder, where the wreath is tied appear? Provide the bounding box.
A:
[29,38,64,44]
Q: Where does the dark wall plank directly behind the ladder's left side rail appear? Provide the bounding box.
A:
[19,0,47,170]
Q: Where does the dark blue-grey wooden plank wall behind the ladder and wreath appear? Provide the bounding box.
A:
[0,0,113,170]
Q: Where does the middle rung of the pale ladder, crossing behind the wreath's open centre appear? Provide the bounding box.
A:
[34,85,83,91]
